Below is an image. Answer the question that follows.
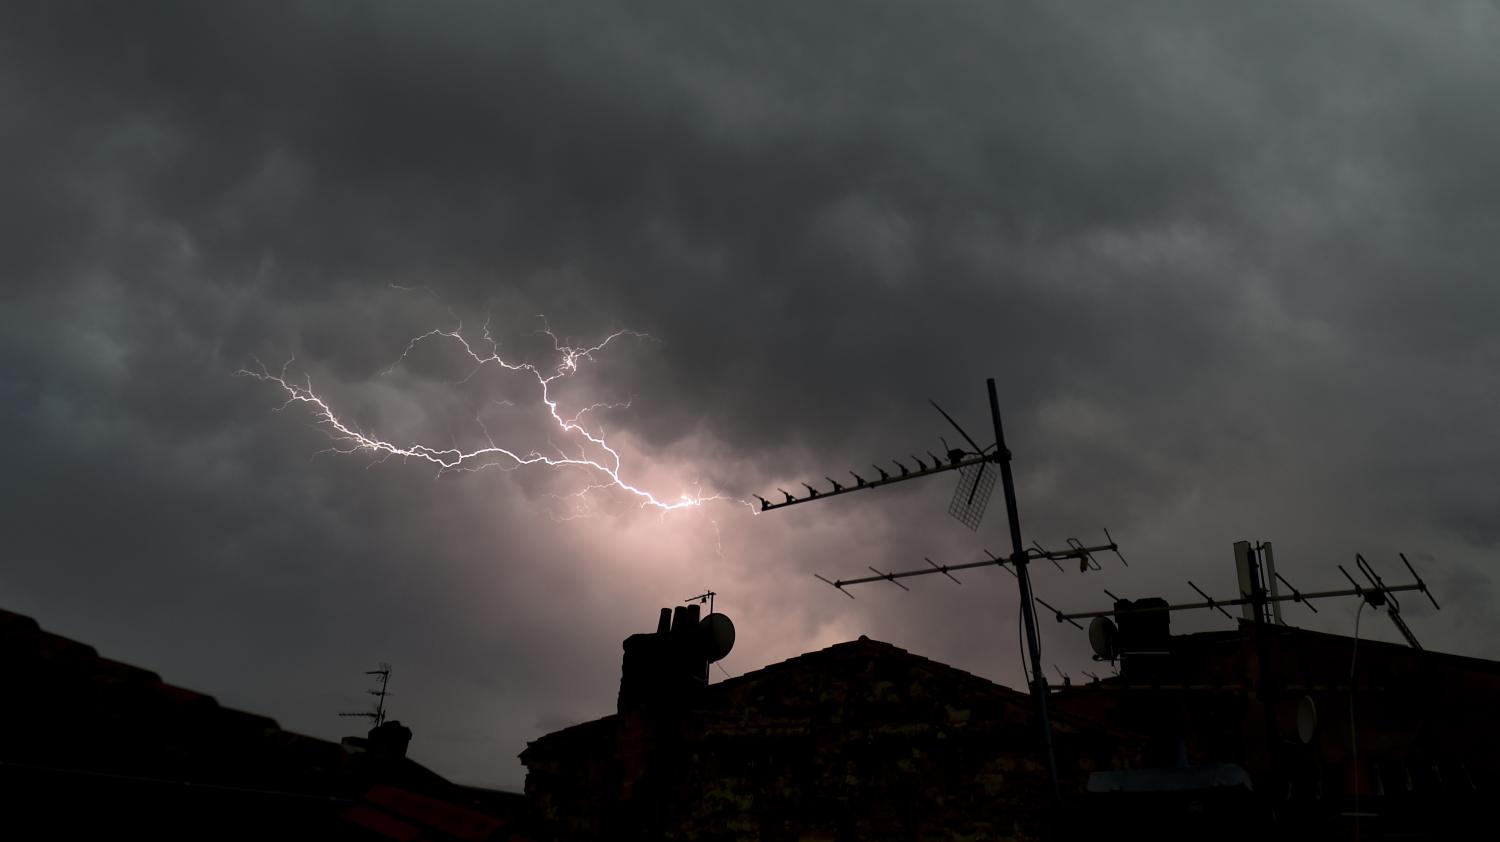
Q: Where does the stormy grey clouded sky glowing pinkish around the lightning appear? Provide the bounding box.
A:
[0,0,1500,788]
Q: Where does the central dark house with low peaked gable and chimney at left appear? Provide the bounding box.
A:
[521,606,1142,840]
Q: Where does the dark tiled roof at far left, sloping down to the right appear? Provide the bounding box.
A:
[0,611,524,840]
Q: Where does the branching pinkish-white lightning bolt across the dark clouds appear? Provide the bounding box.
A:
[236,318,729,519]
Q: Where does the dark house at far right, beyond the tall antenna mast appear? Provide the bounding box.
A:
[1052,611,1500,839]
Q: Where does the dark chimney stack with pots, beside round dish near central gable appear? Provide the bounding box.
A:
[618,605,708,713]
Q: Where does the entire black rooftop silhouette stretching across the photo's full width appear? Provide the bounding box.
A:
[0,585,1500,840]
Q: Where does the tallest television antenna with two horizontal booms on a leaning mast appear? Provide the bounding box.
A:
[756,377,1125,804]
